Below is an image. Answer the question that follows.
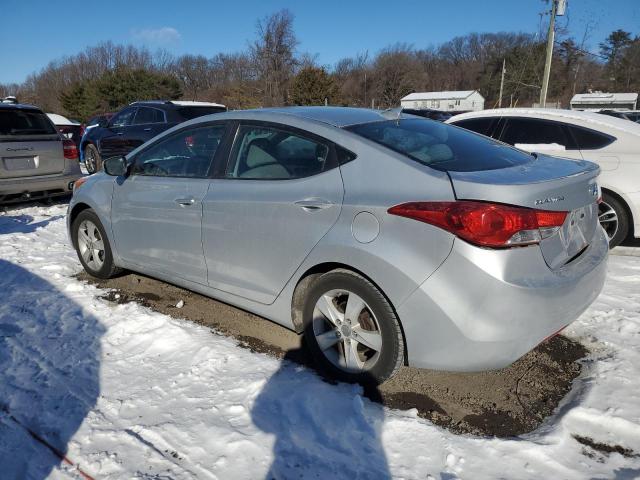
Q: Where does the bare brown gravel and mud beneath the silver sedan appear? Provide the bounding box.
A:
[79,273,587,441]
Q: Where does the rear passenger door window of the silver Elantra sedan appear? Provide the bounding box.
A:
[227,126,329,180]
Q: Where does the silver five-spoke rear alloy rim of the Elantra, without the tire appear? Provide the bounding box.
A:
[312,290,382,373]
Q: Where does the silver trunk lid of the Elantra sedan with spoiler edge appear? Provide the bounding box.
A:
[448,155,600,270]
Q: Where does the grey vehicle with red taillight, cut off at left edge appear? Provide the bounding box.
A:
[0,103,81,203]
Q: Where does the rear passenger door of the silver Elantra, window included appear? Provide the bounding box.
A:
[203,124,344,304]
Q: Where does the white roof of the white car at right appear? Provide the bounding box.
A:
[446,108,640,136]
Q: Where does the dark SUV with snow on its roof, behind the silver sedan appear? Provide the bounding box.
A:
[80,100,227,173]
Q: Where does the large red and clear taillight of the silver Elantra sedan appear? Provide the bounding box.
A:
[388,200,567,248]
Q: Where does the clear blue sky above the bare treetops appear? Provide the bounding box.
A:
[0,0,640,83]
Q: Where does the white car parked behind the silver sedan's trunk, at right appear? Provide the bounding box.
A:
[446,108,640,248]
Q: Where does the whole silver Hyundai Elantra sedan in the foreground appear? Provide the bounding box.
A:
[67,107,608,382]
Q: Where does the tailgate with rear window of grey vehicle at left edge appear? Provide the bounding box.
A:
[0,107,65,179]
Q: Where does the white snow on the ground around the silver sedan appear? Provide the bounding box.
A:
[0,205,640,480]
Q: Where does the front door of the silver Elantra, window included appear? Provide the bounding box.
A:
[111,123,226,284]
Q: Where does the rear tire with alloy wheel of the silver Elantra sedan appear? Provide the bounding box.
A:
[303,269,404,385]
